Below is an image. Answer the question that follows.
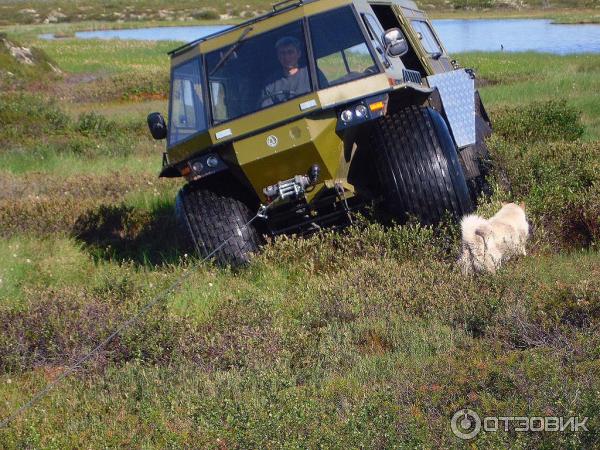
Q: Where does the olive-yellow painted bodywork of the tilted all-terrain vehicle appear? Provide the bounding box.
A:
[167,0,447,201]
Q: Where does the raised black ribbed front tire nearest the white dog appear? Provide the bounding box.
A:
[372,106,473,224]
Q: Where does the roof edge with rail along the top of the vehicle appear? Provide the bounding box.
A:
[169,0,418,57]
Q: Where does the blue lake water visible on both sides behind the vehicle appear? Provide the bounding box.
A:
[40,19,600,55]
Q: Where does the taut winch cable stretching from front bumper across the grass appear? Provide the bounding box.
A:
[0,204,270,429]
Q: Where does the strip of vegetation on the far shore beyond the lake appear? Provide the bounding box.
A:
[0,0,600,27]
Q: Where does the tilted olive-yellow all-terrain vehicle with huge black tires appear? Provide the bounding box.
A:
[148,0,491,265]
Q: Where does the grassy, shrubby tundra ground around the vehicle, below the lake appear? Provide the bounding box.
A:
[0,10,600,448]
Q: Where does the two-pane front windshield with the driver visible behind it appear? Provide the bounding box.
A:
[206,7,379,125]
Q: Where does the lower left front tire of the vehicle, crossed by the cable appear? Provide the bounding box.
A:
[175,180,260,267]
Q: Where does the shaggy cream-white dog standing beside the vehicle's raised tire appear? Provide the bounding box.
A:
[458,203,529,274]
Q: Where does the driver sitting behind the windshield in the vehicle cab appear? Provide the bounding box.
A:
[260,36,310,108]
